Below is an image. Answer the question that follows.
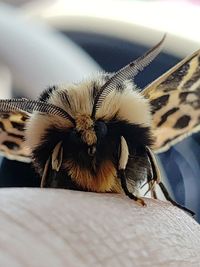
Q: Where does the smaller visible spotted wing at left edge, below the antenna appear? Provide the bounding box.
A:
[0,112,31,162]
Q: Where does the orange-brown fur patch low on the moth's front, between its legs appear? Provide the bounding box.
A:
[64,160,121,193]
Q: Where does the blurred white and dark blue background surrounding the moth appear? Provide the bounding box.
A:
[0,0,200,222]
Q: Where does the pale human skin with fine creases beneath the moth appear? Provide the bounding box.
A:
[0,188,200,267]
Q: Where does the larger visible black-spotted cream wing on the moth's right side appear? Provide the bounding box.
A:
[142,50,200,153]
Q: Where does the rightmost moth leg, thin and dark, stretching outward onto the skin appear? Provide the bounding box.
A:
[147,147,195,216]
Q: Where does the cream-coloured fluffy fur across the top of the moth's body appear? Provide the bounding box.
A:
[26,74,151,152]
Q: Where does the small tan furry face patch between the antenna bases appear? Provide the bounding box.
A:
[75,114,97,146]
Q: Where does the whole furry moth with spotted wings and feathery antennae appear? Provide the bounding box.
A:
[0,37,200,214]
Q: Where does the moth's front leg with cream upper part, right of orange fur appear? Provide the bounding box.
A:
[118,136,146,206]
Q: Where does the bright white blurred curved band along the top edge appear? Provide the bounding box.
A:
[24,0,200,57]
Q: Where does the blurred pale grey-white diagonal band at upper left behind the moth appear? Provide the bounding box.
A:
[0,4,100,98]
